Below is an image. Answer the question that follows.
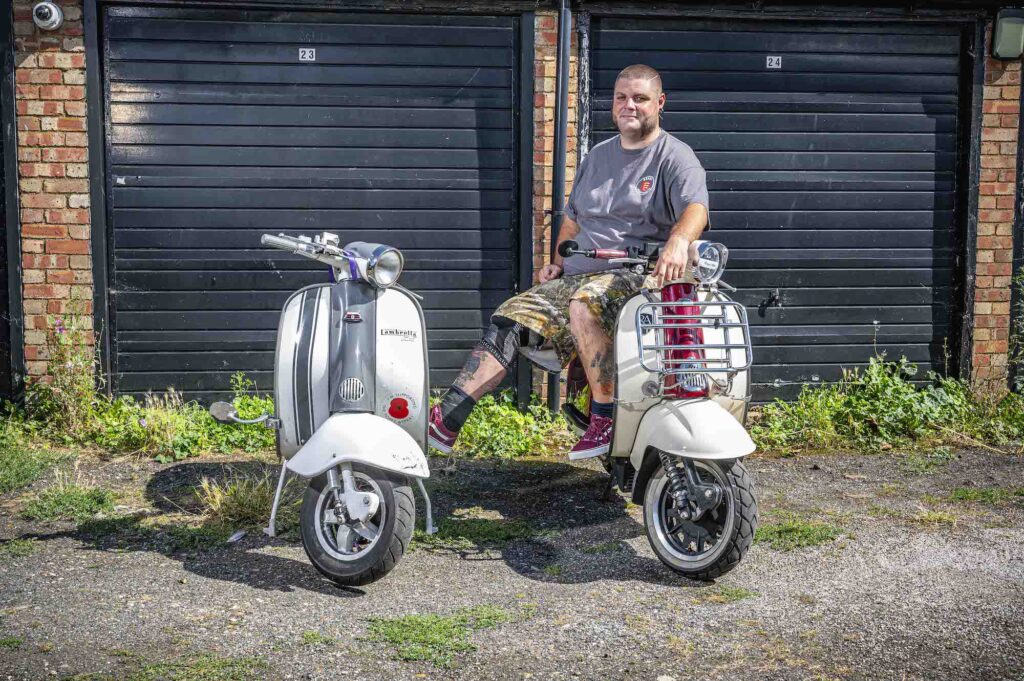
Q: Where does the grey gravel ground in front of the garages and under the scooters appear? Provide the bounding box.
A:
[0,451,1024,681]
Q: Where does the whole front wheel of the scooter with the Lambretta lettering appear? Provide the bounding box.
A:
[299,465,416,587]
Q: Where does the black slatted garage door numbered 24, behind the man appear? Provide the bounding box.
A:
[590,19,962,401]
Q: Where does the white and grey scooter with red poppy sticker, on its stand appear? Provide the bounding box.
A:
[210,232,434,586]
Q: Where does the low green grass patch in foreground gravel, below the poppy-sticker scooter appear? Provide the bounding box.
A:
[369,605,514,668]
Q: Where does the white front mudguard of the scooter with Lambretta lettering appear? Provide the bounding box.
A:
[286,414,430,478]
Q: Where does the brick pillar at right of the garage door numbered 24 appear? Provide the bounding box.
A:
[972,37,1021,392]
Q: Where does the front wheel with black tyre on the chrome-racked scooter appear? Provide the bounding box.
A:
[643,457,758,581]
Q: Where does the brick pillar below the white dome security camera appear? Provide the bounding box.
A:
[14,0,92,376]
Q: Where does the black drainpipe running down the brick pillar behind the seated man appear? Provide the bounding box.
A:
[548,0,572,414]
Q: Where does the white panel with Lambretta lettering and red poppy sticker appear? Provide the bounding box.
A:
[376,289,429,452]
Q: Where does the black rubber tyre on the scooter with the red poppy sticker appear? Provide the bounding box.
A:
[299,464,416,587]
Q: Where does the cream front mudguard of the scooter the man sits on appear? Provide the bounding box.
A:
[630,399,756,470]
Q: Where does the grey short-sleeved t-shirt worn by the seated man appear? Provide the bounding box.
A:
[563,130,709,274]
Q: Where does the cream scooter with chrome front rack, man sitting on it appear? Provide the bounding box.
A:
[536,241,758,580]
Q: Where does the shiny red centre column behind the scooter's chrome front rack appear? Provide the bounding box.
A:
[662,284,708,399]
